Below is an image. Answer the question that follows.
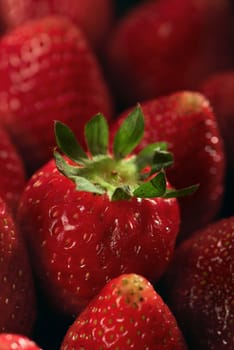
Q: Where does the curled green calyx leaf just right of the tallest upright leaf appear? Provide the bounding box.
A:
[136,142,167,171]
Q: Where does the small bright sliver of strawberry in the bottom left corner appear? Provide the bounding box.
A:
[0,333,40,350]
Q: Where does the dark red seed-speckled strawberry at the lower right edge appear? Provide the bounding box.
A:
[164,217,234,350]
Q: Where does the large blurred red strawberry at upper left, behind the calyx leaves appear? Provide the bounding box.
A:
[0,17,111,174]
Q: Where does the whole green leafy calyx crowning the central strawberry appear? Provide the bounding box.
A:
[54,106,197,200]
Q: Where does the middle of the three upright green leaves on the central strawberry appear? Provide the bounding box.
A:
[85,113,109,155]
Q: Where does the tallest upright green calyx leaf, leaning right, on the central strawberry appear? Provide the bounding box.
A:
[113,106,144,159]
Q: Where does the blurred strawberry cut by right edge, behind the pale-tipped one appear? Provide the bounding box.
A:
[200,70,234,168]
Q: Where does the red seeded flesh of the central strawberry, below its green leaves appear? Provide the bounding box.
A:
[18,160,180,314]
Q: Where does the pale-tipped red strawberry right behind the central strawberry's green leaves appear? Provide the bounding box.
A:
[112,91,225,238]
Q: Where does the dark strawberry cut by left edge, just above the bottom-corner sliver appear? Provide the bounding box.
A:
[0,198,35,334]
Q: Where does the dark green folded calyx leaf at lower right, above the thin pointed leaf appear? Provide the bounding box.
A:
[133,172,166,198]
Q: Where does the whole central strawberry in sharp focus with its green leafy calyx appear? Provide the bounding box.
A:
[18,107,196,314]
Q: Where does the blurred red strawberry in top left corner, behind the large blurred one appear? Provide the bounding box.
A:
[0,0,114,49]
